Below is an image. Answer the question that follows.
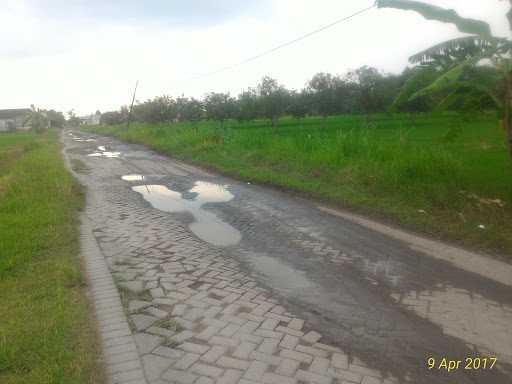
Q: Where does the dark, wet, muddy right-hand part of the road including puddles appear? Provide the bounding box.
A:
[64,132,512,383]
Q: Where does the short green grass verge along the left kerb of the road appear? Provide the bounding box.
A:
[0,132,103,384]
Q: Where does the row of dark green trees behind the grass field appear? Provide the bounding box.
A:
[101,66,493,126]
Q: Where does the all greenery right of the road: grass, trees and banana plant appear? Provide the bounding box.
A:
[90,0,512,257]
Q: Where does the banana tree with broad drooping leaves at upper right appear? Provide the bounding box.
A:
[376,0,512,158]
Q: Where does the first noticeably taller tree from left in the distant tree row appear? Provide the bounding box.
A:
[258,76,289,127]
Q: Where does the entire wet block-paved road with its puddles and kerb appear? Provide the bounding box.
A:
[63,132,512,384]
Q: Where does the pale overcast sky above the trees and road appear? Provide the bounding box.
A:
[0,0,509,114]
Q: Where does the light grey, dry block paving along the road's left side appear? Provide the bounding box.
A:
[65,132,512,384]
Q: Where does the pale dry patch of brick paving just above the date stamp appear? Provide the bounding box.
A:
[394,286,512,363]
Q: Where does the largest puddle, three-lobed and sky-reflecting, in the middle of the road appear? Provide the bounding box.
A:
[132,181,241,246]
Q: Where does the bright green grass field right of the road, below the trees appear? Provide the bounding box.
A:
[86,113,512,258]
